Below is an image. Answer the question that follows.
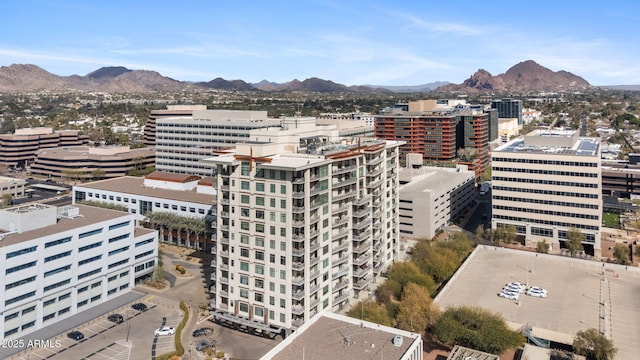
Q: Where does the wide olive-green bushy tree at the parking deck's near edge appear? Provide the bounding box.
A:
[433,306,524,354]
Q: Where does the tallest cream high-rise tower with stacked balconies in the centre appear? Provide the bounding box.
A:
[206,118,402,328]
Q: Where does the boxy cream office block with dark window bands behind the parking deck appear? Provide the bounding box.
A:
[491,130,602,256]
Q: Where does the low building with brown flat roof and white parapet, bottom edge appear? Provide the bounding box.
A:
[260,311,424,360]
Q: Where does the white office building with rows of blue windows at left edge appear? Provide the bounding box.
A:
[0,204,158,339]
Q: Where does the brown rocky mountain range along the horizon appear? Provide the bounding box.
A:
[0,60,608,93]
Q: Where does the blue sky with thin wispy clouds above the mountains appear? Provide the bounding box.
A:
[0,0,640,85]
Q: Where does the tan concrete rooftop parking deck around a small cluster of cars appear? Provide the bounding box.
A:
[435,246,640,359]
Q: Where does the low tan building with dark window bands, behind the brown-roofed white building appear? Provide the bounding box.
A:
[31,146,156,180]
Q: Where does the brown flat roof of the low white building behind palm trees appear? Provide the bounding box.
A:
[74,176,215,205]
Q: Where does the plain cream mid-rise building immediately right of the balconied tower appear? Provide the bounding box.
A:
[399,167,475,239]
